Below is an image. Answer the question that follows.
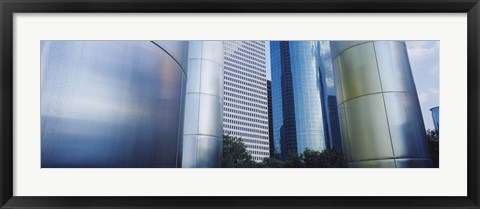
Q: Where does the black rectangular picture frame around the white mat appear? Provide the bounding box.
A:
[0,0,480,208]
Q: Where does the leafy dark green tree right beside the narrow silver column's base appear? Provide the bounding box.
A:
[222,135,257,168]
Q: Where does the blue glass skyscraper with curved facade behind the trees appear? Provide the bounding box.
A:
[270,41,327,158]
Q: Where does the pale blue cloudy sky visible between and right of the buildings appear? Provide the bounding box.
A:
[267,41,440,129]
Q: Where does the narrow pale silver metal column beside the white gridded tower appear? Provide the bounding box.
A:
[182,41,223,168]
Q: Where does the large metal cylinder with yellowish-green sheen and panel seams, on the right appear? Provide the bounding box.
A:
[331,41,432,167]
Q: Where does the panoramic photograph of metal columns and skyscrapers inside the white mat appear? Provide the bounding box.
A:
[39,40,438,169]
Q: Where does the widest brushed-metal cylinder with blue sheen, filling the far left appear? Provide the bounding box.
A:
[41,41,188,168]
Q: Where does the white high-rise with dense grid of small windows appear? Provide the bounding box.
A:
[223,41,270,162]
